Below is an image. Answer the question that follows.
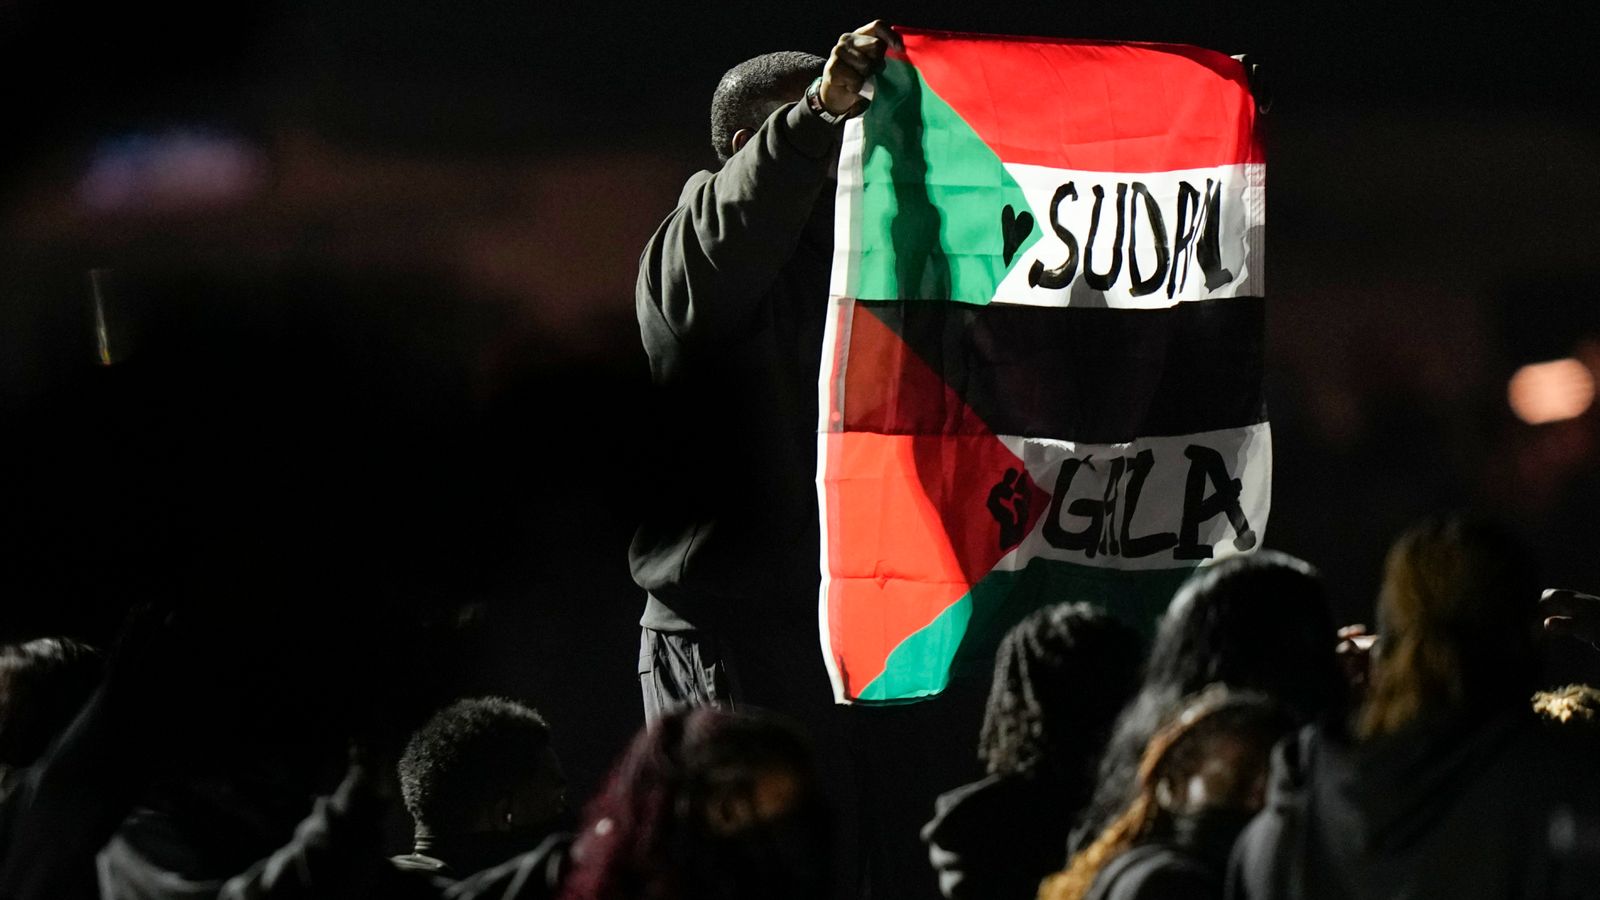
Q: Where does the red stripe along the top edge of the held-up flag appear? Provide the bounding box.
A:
[896,29,1264,173]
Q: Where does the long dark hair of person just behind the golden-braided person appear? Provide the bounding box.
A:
[1072,549,1347,850]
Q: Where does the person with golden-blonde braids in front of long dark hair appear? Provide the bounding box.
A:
[1038,684,1293,900]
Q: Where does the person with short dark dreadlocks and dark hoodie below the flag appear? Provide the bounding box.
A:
[922,604,1144,900]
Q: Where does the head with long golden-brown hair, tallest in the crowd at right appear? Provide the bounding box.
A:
[1358,516,1539,735]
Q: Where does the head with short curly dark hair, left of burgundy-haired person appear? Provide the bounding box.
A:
[400,697,566,871]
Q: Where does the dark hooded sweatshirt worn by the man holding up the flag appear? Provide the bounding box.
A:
[629,104,838,641]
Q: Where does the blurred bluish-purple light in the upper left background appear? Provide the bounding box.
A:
[77,130,267,213]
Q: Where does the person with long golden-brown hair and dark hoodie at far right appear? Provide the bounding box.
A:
[1229,517,1600,900]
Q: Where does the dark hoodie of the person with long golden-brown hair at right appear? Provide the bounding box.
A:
[1227,709,1600,900]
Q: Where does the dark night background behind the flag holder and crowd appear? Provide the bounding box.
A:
[0,0,1600,864]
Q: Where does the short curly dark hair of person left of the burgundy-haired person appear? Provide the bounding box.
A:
[400,697,550,831]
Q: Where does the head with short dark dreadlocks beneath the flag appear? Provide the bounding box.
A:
[978,604,1144,790]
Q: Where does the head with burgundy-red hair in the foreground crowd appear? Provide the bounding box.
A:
[563,709,830,900]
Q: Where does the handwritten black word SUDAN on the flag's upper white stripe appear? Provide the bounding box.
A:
[1027,178,1234,299]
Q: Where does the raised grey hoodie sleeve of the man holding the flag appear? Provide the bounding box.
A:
[637,102,838,346]
